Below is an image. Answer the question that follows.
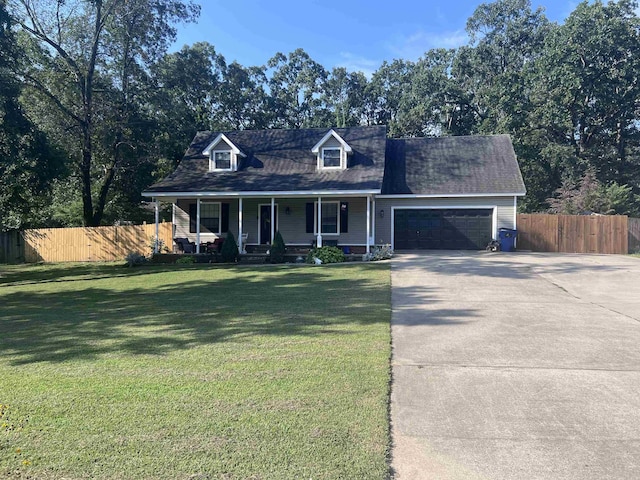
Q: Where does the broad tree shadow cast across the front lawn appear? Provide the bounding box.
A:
[0,265,408,364]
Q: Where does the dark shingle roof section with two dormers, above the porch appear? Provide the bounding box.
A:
[147,126,386,193]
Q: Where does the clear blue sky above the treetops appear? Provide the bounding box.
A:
[174,0,578,74]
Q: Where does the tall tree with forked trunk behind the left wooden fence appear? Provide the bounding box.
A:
[12,0,199,225]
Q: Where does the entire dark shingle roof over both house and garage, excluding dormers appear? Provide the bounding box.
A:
[146,126,525,196]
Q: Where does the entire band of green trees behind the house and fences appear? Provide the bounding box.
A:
[0,0,640,228]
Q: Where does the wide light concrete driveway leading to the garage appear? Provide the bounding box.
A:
[391,252,640,480]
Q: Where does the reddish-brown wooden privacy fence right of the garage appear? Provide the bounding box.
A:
[517,213,629,254]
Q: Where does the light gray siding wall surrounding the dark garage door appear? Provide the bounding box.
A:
[375,197,515,244]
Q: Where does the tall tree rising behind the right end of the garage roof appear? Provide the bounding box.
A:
[451,0,552,211]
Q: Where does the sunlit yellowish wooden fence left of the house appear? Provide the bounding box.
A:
[22,222,173,263]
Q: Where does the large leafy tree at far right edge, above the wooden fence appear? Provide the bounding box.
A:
[534,0,640,192]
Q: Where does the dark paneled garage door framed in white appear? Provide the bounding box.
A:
[393,208,494,250]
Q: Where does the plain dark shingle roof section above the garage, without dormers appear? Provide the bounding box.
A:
[382,135,525,195]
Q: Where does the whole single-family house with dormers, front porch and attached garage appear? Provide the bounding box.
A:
[143,126,525,253]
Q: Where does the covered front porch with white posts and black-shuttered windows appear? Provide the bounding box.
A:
[154,192,376,253]
